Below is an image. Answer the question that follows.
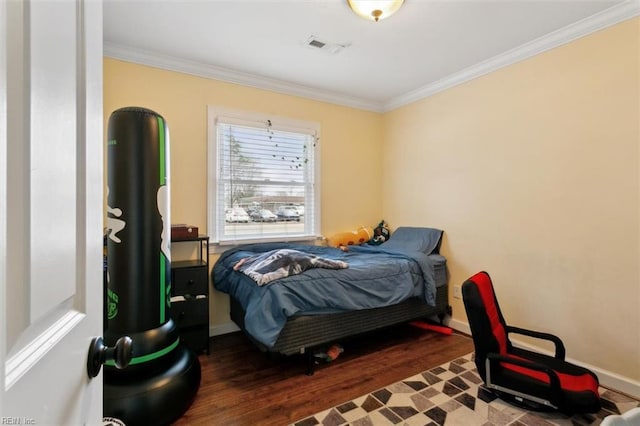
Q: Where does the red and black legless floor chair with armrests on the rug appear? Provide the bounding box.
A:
[462,272,600,415]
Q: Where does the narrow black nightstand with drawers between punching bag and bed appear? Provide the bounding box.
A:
[171,235,209,354]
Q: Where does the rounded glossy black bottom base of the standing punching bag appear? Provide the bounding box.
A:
[103,344,201,426]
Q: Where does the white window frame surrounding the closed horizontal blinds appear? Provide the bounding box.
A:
[207,105,322,248]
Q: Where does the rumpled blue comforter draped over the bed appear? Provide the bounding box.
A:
[212,231,442,348]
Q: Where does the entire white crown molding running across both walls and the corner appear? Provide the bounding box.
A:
[104,0,640,113]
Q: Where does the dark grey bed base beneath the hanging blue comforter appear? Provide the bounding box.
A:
[229,284,451,375]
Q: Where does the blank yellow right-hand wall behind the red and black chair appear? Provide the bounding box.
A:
[382,19,640,381]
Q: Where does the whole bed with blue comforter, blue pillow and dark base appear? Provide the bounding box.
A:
[211,227,451,374]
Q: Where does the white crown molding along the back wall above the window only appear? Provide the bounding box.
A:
[104,42,382,112]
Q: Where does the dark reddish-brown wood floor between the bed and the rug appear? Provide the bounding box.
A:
[175,324,473,426]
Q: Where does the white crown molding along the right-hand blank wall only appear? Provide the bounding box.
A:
[382,0,640,112]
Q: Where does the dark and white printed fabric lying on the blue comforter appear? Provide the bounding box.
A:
[233,249,349,285]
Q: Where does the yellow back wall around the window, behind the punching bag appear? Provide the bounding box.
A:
[104,58,382,332]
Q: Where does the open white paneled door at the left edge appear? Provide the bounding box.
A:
[0,0,103,425]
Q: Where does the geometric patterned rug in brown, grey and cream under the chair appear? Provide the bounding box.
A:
[293,354,640,426]
